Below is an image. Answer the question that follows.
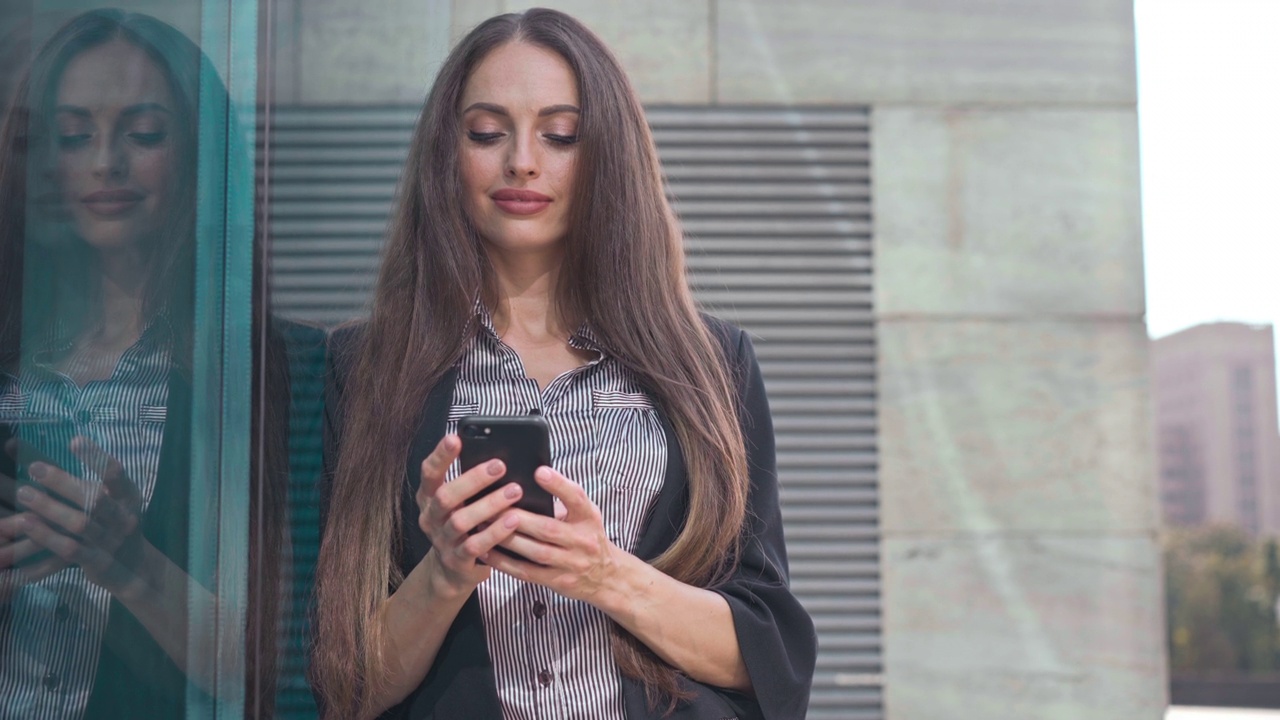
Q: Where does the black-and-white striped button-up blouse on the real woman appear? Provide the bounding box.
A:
[447,307,667,720]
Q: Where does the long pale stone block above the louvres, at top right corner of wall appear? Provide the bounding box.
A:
[716,0,1137,104]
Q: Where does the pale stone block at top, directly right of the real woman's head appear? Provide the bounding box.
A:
[494,0,712,104]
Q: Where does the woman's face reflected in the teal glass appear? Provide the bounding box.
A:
[54,40,177,252]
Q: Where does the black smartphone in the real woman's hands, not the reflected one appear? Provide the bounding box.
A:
[458,415,556,518]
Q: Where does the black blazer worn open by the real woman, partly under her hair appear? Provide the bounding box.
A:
[324,318,817,720]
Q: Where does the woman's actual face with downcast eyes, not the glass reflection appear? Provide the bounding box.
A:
[460,42,579,252]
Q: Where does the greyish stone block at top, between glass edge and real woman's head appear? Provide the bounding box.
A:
[297,0,451,104]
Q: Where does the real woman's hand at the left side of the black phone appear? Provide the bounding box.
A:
[417,434,522,594]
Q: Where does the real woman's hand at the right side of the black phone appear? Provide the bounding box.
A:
[485,466,623,605]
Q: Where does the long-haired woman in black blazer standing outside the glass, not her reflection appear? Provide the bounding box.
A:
[312,9,815,719]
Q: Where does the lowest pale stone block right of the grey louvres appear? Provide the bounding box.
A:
[883,536,1167,720]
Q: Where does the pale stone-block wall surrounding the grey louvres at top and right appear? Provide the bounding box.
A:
[278,0,1166,720]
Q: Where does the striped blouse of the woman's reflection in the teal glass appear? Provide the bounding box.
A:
[0,323,170,720]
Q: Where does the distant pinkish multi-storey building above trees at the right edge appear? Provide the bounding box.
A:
[1151,323,1280,536]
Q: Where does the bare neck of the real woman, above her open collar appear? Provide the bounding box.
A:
[489,242,570,342]
